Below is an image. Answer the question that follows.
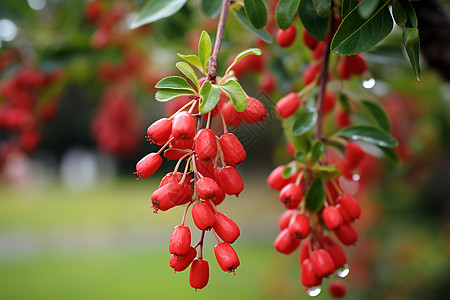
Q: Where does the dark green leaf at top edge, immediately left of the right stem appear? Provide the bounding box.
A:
[298,0,328,41]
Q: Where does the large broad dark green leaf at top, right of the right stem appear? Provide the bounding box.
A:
[331,1,393,55]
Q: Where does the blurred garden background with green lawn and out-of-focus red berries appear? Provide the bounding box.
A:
[0,0,450,299]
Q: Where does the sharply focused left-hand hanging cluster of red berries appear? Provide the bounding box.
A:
[136,88,266,289]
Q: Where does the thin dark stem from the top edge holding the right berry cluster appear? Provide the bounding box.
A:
[314,1,334,140]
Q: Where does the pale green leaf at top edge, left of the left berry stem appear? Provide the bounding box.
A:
[131,0,187,29]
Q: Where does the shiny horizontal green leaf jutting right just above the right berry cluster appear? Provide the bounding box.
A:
[337,125,398,147]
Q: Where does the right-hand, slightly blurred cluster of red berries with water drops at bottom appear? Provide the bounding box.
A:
[267,142,365,297]
